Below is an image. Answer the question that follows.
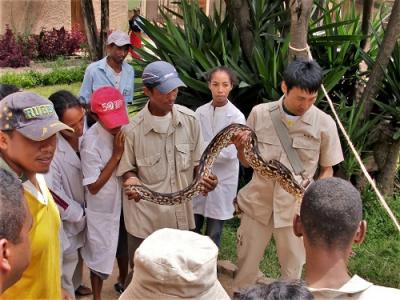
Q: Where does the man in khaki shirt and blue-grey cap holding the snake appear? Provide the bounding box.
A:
[117,61,217,278]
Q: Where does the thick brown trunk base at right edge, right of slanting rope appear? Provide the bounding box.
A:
[374,124,400,196]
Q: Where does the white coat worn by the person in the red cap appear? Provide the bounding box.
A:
[81,123,122,274]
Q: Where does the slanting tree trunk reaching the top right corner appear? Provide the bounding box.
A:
[361,0,400,118]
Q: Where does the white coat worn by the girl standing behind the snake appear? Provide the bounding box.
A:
[193,101,246,220]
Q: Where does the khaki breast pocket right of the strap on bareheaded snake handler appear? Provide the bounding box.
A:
[292,136,321,169]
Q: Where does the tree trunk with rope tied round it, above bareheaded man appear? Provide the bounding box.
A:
[289,0,313,62]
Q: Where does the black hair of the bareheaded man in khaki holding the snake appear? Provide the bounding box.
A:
[282,59,322,93]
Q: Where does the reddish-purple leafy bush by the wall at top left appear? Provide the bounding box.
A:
[0,26,85,68]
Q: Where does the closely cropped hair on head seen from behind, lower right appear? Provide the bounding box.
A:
[300,177,362,249]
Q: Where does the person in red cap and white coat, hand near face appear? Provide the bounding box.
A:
[81,87,129,300]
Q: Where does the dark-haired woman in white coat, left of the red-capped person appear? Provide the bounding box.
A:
[45,91,91,299]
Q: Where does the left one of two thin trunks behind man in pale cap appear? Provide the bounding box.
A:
[81,0,99,60]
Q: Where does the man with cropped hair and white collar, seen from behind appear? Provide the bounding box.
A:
[293,178,400,300]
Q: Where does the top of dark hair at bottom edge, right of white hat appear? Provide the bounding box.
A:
[233,280,314,300]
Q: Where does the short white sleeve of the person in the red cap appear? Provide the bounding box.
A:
[81,137,104,186]
